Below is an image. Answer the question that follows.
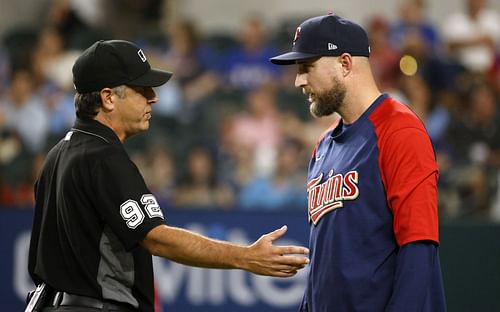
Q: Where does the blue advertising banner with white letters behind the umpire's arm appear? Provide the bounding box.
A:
[0,209,308,312]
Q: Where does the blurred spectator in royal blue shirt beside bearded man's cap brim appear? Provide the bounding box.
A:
[222,15,281,91]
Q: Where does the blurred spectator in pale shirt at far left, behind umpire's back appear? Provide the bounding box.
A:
[0,69,49,152]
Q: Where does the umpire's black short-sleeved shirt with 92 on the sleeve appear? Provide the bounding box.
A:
[28,118,165,311]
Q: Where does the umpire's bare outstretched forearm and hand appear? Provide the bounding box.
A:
[142,225,309,277]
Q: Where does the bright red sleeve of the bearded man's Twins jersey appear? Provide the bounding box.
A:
[379,126,439,246]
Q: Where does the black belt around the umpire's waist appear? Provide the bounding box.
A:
[52,291,137,312]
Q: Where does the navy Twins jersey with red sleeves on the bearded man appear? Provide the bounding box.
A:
[301,94,441,312]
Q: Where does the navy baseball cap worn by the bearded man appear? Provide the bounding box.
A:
[270,14,370,65]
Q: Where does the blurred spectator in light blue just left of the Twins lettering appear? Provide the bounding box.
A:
[237,140,307,210]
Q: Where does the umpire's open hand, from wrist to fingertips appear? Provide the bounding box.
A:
[243,225,309,277]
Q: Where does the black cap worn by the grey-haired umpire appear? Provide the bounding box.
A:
[73,40,172,93]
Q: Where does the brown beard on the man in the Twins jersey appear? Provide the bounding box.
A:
[309,78,346,118]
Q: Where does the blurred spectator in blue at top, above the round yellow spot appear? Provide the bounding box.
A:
[390,0,441,54]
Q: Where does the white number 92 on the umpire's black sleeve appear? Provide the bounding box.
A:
[120,194,163,229]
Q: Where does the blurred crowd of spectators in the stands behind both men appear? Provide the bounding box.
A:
[0,0,500,220]
